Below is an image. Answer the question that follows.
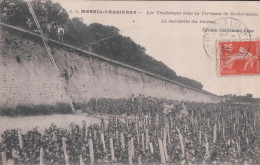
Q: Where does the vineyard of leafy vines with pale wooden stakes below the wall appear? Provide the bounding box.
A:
[0,99,260,164]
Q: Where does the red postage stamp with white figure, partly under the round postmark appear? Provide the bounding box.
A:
[218,41,260,76]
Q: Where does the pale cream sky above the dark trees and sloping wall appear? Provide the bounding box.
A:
[54,0,260,98]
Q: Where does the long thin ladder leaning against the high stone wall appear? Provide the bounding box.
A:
[27,2,75,112]
